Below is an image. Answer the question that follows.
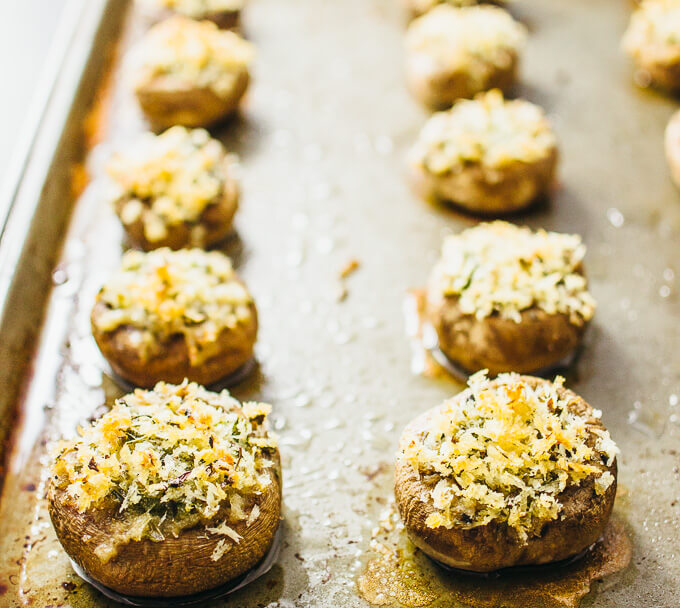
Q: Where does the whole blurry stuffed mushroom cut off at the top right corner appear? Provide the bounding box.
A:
[623,0,680,91]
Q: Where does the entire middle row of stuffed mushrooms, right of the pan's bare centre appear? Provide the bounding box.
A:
[395,0,618,588]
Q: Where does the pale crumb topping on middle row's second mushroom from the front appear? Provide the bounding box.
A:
[431,221,596,326]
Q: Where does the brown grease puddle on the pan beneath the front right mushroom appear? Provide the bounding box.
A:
[356,516,632,608]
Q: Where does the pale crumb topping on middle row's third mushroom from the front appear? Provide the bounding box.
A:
[413,90,557,175]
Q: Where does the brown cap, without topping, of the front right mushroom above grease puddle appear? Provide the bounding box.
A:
[394,376,617,572]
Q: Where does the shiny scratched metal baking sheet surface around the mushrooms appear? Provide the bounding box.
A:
[0,0,680,608]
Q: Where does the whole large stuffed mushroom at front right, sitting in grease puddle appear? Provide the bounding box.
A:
[395,372,618,572]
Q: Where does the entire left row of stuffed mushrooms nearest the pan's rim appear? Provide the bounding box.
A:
[48,0,282,602]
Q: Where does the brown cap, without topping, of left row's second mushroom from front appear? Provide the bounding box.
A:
[91,300,258,388]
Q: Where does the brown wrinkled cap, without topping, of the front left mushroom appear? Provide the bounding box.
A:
[48,450,281,597]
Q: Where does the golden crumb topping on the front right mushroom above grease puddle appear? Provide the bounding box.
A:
[398,371,618,542]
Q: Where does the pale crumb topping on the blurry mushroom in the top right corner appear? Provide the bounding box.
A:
[623,0,680,54]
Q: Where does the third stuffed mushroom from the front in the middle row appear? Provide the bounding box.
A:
[409,90,558,215]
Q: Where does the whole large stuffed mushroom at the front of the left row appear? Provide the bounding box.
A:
[47,382,281,597]
